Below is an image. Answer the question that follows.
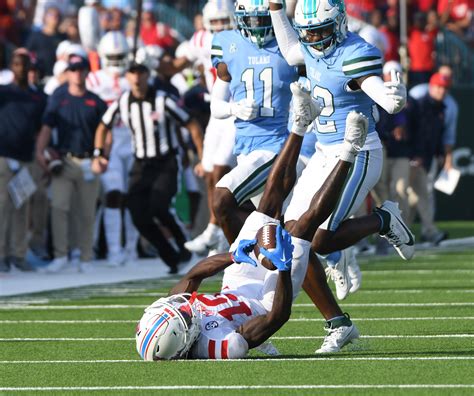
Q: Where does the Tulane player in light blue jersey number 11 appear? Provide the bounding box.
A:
[211,0,297,243]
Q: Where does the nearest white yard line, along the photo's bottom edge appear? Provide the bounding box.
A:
[0,384,474,392]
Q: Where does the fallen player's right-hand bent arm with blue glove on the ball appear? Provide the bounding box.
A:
[237,226,293,348]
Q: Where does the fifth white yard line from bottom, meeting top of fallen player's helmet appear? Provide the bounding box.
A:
[0,302,474,311]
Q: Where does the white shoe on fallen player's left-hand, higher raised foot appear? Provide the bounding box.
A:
[290,82,321,136]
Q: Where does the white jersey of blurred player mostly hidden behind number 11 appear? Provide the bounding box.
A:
[186,29,217,92]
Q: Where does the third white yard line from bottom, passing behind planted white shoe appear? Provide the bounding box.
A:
[0,334,474,342]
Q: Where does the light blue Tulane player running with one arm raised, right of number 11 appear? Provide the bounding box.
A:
[270,0,414,306]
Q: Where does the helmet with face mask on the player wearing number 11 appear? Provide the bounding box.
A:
[235,0,275,48]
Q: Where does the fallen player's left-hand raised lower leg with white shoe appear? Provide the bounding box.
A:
[257,82,321,219]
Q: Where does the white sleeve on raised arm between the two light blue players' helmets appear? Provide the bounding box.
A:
[270,8,304,66]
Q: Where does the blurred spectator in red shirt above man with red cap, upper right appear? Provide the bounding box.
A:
[408,12,438,86]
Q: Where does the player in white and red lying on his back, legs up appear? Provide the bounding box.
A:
[136,85,367,360]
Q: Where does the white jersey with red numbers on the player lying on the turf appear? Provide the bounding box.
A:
[191,293,267,359]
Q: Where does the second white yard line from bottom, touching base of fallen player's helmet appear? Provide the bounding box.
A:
[0,356,474,365]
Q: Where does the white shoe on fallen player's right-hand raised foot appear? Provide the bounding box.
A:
[340,111,369,162]
